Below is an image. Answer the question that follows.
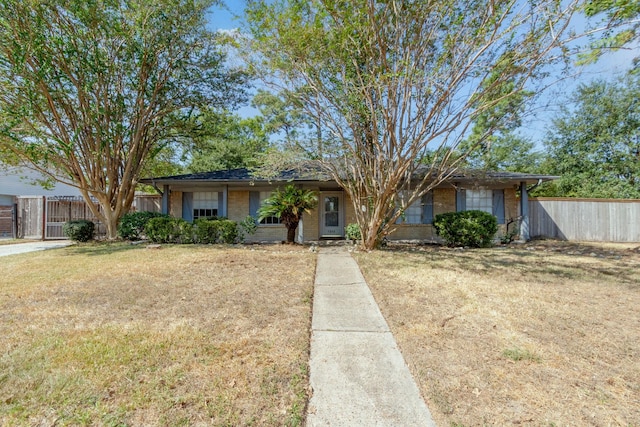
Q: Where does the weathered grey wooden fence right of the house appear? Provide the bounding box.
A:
[529,197,640,242]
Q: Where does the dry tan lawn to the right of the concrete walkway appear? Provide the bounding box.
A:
[355,242,640,426]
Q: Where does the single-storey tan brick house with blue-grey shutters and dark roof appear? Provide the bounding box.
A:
[142,169,556,242]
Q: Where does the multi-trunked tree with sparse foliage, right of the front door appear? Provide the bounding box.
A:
[247,0,579,249]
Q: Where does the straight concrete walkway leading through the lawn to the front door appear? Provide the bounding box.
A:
[307,247,435,427]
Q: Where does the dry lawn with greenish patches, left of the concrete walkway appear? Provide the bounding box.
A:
[0,245,315,426]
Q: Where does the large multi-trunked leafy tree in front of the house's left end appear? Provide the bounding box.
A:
[0,0,245,238]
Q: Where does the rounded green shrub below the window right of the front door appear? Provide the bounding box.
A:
[433,211,498,248]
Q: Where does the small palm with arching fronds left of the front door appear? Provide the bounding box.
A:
[258,184,318,243]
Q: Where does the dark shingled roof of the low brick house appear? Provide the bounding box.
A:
[140,166,559,185]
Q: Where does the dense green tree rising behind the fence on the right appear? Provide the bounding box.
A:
[538,75,640,198]
